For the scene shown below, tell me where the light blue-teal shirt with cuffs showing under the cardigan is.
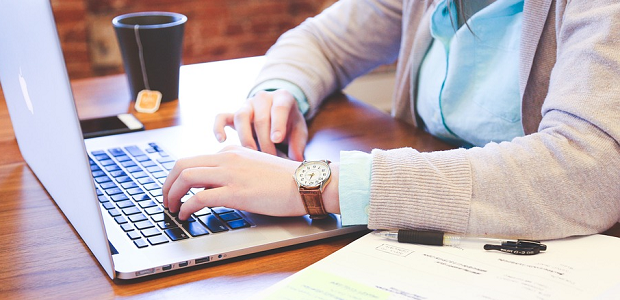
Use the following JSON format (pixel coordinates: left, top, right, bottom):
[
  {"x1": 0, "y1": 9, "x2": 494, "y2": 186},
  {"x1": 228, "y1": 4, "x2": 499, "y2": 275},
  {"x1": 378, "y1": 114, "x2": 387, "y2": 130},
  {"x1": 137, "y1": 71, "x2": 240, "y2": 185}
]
[{"x1": 254, "y1": 0, "x2": 524, "y2": 226}]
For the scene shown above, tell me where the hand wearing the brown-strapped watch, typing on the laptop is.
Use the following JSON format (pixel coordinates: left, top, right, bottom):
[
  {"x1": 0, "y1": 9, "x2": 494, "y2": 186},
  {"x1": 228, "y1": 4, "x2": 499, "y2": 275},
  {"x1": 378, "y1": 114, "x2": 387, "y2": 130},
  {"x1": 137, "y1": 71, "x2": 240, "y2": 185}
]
[{"x1": 163, "y1": 146, "x2": 339, "y2": 220}]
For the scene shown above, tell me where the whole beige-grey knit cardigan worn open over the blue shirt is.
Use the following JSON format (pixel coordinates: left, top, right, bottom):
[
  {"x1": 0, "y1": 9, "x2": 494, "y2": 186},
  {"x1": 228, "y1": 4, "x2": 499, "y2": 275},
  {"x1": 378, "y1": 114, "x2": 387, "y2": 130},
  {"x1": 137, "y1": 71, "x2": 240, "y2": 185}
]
[{"x1": 252, "y1": 0, "x2": 620, "y2": 239}]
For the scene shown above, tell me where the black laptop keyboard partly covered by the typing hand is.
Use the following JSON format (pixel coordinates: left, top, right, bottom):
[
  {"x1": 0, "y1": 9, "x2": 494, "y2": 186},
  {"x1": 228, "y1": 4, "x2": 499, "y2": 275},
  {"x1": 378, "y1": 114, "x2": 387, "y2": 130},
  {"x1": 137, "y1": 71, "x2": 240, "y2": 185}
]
[{"x1": 90, "y1": 143, "x2": 252, "y2": 248}]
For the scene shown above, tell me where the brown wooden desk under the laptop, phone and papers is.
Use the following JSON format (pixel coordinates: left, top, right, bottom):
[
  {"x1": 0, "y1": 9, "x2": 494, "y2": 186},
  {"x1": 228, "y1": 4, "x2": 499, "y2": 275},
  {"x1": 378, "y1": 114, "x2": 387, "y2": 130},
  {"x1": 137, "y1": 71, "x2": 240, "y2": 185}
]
[{"x1": 0, "y1": 58, "x2": 620, "y2": 299}]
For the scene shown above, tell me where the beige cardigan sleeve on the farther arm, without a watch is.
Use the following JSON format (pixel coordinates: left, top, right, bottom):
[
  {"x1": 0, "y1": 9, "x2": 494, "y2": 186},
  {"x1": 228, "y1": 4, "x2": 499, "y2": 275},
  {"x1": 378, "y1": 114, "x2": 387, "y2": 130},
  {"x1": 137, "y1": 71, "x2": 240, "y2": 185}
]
[{"x1": 256, "y1": 0, "x2": 402, "y2": 118}]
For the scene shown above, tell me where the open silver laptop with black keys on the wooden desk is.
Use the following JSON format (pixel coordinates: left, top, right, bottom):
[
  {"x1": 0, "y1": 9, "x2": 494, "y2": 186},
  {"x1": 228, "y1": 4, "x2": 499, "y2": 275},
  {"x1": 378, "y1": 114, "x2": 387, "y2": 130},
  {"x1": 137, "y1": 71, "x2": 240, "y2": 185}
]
[{"x1": 0, "y1": 0, "x2": 365, "y2": 279}]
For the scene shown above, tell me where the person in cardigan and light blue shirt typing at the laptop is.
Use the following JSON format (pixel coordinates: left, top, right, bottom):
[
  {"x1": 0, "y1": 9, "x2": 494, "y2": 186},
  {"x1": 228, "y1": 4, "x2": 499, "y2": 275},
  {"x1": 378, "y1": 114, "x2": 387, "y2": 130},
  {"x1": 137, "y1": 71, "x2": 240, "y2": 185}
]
[{"x1": 163, "y1": 0, "x2": 620, "y2": 239}]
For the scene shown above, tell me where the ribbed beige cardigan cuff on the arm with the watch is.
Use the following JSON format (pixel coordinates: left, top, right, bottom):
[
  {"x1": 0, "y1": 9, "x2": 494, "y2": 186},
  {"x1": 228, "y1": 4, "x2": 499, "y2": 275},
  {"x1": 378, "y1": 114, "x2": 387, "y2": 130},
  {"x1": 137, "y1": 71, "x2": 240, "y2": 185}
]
[{"x1": 368, "y1": 148, "x2": 472, "y2": 233}]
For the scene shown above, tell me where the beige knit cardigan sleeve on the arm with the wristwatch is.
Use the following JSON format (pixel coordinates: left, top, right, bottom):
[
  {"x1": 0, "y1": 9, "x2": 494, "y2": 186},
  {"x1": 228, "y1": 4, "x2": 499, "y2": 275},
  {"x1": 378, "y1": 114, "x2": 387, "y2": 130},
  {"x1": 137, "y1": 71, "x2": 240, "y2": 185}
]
[{"x1": 369, "y1": 1, "x2": 620, "y2": 239}]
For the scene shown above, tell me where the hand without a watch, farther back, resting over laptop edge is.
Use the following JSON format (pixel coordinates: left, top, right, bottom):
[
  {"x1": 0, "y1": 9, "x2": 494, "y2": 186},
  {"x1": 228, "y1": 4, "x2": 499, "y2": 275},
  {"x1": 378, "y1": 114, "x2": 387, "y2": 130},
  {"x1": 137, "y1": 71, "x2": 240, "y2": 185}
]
[{"x1": 213, "y1": 90, "x2": 308, "y2": 161}]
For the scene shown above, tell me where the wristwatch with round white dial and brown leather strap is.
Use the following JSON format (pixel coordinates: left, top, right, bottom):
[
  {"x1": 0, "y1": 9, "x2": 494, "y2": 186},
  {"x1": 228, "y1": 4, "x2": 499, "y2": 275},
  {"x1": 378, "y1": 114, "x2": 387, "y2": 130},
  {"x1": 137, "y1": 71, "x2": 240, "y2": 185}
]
[{"x1": 293, "y1": 160, "x2": 331, "y2": 219}]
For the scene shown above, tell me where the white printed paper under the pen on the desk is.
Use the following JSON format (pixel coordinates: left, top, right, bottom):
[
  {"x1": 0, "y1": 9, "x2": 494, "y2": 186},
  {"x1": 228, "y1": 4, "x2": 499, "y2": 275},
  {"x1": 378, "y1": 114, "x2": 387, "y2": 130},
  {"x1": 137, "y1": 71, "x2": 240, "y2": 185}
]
[{"x1": 261, "y1": 234, "x2": 620, "y2": 300}]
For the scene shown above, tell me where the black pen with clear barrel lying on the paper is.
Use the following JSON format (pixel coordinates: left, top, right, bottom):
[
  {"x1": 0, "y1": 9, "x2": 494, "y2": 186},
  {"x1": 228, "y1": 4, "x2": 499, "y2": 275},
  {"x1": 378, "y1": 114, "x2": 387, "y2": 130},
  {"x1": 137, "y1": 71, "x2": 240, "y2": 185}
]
[{"x1": 373, "y1": 229, "x2": 547, "y2": 255}]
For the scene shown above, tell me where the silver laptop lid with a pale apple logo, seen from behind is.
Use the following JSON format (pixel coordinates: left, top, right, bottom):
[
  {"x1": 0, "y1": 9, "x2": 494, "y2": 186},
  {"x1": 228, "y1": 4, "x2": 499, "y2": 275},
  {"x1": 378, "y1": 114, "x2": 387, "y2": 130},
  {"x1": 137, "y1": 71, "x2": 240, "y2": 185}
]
[{"x1": 0, "y1": 0, "x2": 114, "y2": 277}]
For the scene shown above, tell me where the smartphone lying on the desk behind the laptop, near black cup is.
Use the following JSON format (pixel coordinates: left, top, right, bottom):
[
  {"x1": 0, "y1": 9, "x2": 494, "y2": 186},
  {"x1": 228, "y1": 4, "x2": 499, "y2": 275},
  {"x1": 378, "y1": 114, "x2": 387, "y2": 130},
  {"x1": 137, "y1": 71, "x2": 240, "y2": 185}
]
[{"x1": 80, "y1": 114, "x2": 144, "y2": 139}]
